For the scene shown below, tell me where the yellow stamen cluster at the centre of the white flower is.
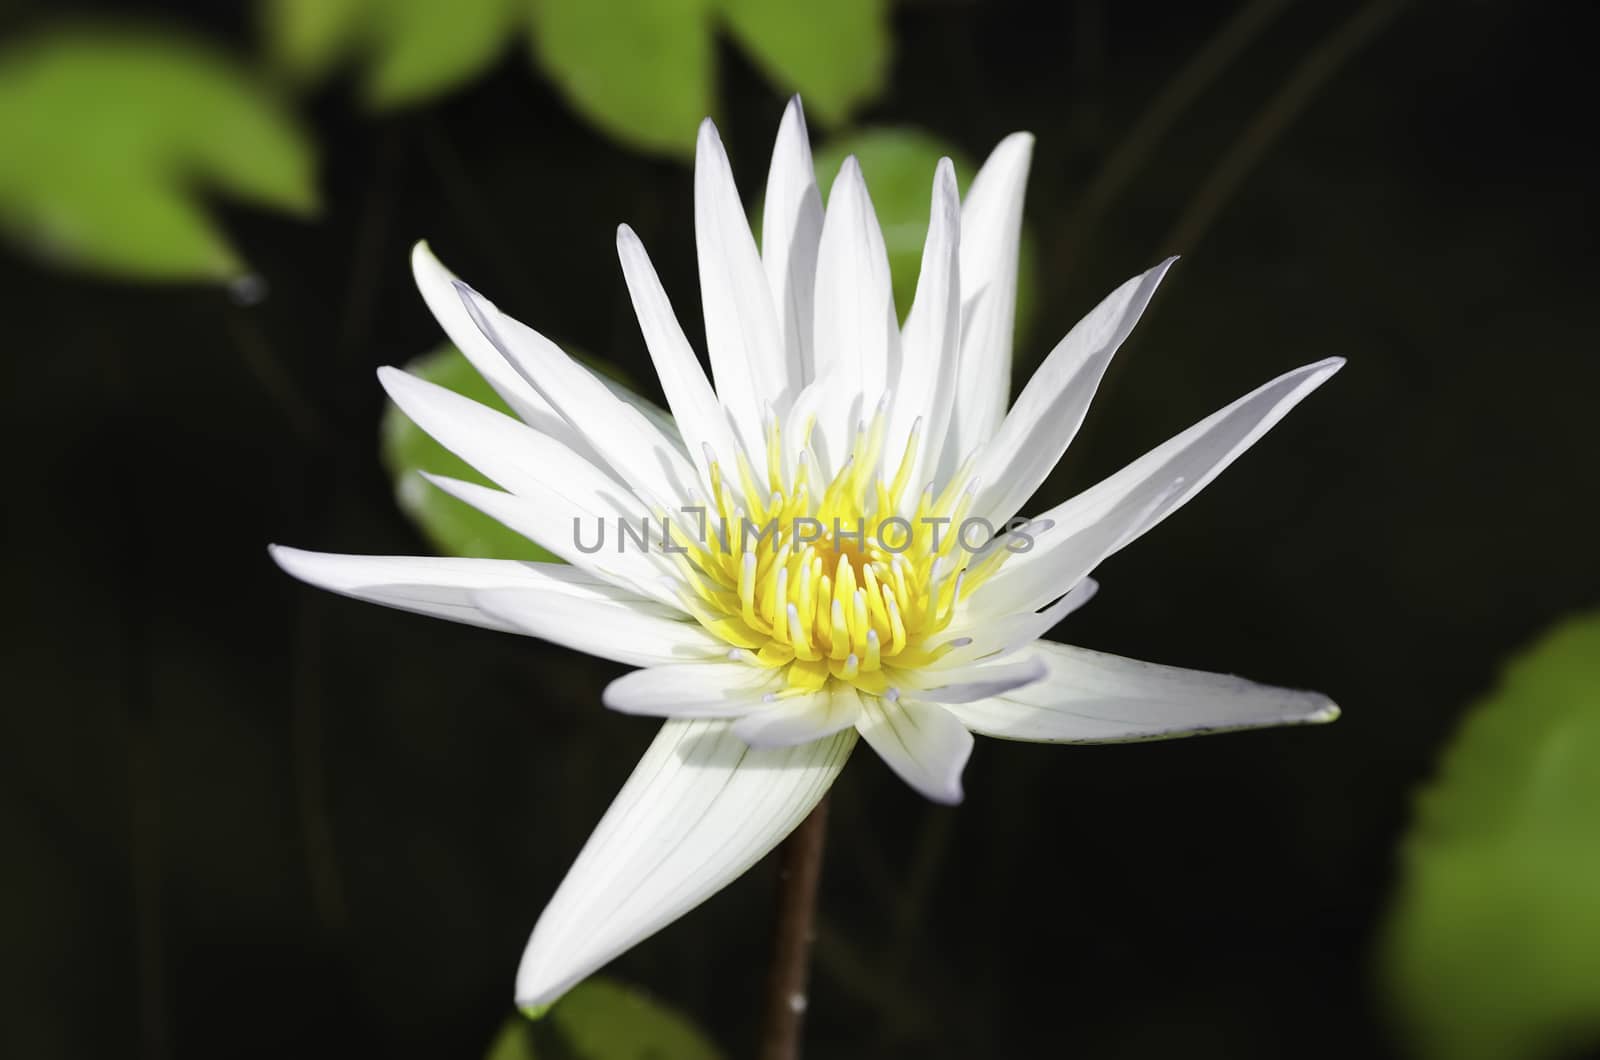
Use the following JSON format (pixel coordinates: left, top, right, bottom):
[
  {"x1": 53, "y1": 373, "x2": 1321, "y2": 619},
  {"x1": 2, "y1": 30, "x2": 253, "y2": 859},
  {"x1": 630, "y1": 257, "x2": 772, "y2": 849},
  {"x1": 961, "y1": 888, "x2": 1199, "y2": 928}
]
[{"x1": 678, "y1": 410, "x2": 1006, "y2": 695}]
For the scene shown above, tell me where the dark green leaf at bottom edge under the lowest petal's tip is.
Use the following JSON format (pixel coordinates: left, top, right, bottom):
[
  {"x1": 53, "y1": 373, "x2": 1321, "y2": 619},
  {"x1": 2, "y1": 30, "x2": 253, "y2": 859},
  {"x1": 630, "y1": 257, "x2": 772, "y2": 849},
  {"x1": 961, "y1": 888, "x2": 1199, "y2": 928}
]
[{"x1": 485, "y1": 977, "x2": 722, "y2": 1060}]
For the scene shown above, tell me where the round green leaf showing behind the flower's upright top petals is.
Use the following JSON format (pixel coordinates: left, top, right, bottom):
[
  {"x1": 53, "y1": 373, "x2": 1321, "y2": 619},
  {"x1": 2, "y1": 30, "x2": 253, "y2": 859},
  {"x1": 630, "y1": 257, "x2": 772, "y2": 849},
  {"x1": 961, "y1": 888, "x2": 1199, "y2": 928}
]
[{"x1": 814, "y1": 128, "x2": 1034, "y2": 341}]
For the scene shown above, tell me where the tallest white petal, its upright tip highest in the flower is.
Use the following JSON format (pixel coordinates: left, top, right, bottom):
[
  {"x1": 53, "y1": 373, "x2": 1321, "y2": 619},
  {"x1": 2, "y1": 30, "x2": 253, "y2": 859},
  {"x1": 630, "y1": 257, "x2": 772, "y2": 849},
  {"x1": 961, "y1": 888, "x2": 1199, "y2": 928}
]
[{"x1": 762, "y1": 96, "x2": 822, "y2": 390}]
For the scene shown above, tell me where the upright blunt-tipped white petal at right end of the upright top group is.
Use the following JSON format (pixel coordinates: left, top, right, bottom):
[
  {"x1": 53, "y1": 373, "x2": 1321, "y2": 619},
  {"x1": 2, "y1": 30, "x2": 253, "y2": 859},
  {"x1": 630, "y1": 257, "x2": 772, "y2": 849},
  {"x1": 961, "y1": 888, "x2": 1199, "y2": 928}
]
[{"x1": 946, "y1": 133, "x2": 1034, "y2": 468}]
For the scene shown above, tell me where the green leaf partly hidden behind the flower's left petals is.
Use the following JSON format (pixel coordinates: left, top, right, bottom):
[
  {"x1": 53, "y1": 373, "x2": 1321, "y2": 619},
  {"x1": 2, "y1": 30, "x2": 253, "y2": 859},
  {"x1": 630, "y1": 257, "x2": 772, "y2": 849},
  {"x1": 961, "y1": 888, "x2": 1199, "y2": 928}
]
[{"x1": 379, "y1": 346, "x2": 555, "y2": 560}]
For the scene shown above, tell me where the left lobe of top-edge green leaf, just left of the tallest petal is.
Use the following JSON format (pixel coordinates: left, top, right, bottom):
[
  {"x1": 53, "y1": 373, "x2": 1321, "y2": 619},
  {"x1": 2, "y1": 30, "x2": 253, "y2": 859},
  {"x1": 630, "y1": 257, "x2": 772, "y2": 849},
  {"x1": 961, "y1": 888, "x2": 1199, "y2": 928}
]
[{"x1": 533, "y1": 0, "x2": 715, "y2": 159}]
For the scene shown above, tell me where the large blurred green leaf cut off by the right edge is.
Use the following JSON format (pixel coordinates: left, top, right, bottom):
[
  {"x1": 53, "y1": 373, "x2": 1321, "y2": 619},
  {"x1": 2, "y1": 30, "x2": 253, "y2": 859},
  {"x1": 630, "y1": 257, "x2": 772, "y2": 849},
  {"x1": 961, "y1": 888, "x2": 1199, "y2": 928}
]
[{"x1": 1386, "y1": 615, "x2": 1600, "y2": 1060}]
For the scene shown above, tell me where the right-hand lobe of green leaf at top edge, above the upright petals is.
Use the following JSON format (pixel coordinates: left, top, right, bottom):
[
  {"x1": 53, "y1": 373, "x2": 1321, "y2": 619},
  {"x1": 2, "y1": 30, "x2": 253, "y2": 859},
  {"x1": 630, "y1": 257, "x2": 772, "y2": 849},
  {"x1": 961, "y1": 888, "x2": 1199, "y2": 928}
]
[{"x1": 720, "y1": 0, "x2": 891, "y2": 125}]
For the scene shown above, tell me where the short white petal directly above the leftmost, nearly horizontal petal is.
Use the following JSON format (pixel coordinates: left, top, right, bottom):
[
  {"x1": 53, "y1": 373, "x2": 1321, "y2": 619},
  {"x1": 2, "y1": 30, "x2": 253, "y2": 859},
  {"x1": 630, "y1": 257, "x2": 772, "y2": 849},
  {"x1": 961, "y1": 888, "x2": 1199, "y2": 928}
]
[{"x1": 422, "y1": 473, "x2": 678, "y2": 607}]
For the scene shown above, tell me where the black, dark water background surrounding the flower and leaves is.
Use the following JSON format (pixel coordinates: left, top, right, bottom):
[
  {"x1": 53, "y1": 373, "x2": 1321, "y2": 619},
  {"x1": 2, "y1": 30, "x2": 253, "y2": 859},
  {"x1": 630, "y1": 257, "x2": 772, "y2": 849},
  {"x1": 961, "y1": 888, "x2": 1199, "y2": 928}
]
[{"x1": 0, "y1": 0, "x2": 1600, "y2": 1057}]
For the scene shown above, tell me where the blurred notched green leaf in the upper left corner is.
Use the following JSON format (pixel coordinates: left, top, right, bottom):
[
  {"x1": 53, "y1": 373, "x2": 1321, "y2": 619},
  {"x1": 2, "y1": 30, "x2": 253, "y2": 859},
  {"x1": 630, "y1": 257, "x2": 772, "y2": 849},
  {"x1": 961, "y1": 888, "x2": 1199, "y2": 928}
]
[{"x1": 0, "y1": 29, "x2": 317, "y2": 280}]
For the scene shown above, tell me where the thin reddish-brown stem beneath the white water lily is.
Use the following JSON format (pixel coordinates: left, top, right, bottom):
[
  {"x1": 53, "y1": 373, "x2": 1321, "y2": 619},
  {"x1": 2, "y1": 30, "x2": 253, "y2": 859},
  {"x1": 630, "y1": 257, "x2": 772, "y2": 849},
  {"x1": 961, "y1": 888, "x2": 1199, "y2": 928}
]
[{"x1": 760, "y1": 796, "x2": 827, "y2": 1060}]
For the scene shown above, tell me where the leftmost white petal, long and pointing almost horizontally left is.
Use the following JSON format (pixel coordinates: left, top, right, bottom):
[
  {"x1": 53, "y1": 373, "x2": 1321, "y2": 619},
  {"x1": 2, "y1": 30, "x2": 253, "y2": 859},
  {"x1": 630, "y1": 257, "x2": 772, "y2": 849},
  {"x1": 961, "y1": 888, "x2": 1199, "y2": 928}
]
[{"x1": 267, "y1": 544, "x2": 656, "y2": 631}]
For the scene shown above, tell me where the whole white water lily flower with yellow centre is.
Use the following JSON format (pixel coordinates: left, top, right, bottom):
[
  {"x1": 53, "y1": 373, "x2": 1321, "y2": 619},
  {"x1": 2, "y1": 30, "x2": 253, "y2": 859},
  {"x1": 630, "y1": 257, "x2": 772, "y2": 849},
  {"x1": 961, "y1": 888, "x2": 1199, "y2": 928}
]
[{"x1": 274, "y1": 101, "x2": 1341, "y2": 1006}]
